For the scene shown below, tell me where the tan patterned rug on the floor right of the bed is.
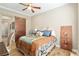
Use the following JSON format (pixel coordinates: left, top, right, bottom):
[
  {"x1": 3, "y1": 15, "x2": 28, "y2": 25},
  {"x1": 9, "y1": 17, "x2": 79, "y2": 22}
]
[{"x1": 47, "y1": 47, "x2": 70, "y2": 56}]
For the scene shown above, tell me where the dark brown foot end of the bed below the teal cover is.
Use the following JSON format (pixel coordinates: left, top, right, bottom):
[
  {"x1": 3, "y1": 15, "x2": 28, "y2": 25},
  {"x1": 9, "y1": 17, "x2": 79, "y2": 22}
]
[{"x1": 18, "y1": 40, "x2": 31, "y2": 55}]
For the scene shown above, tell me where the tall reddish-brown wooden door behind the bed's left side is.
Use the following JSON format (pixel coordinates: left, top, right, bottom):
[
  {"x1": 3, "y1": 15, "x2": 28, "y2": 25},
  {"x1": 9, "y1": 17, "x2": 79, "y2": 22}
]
[{"x1": 15, "y1": 17, "x2": 26, "y2": 45}]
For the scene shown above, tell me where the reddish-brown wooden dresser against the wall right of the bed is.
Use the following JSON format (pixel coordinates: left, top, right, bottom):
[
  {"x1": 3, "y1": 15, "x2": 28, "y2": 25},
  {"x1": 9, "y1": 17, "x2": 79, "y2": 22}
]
[{"x1": 60, "y1": 26, "x2": 72, "y2": 50}]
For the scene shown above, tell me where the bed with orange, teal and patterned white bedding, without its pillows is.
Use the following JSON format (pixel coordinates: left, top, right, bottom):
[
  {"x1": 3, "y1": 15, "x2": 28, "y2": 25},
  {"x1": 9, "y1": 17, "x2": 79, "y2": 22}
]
[{"x1": 17, "y1": 35, "x2": 56, "y2": 56}]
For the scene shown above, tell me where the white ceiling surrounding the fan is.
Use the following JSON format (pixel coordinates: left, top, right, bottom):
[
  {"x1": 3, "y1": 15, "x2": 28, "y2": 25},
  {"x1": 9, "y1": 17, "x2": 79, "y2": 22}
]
[{"x1": 0, "y1": 3, "x2": 66, "y2": 16}]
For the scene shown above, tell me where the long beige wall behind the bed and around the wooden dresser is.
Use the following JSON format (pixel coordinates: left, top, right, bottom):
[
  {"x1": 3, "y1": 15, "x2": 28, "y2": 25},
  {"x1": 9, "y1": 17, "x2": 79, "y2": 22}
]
[{"x1": 32, "y1": 4, "x2": 78, "y2": 49}]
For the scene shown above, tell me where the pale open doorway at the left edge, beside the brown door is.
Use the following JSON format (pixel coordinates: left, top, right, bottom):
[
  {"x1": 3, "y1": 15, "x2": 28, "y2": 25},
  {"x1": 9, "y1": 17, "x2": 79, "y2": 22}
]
[{"x1": 0, "y1": 15, "x2": 13, "y2": 46}]
